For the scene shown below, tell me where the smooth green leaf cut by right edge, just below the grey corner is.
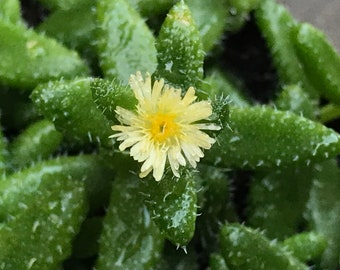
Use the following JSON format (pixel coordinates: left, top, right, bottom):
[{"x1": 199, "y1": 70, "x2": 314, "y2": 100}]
[{"x1": 294, "y1": 23, "x2": 340, "y2": 104}]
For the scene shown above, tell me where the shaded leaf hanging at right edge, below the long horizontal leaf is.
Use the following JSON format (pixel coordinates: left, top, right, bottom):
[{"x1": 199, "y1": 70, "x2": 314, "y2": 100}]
[{"x1": 308, "y1": 160, "x2": 340, "y2": 269}]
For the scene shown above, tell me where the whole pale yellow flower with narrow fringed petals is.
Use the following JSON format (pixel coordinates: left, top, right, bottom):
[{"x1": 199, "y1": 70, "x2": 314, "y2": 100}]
[{"x1": 110, "y1": 72, "x2": 220, "y2": 181}]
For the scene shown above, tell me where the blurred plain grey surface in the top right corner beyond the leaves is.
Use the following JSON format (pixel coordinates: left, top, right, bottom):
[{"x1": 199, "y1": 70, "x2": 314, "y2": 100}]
[{"x1": 278, "y1": 0, "x2": 340, "y2": 52}]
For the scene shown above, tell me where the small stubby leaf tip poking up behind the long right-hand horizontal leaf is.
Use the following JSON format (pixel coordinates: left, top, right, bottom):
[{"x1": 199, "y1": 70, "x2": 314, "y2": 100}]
[{"x1": 275, "y1": 85, "x2": 318, "y2": 120}]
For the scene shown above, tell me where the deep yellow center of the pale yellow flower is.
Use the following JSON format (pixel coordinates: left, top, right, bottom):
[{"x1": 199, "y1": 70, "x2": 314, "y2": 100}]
[{"x1": 150, "y1": 114, "x2": 179, "y2": 142}]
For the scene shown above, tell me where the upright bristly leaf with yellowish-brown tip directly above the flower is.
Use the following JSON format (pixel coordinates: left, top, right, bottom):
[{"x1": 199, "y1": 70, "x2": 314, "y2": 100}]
[{"x1": 155, "y1": 1, "x2": 204, "y2": 90}]
